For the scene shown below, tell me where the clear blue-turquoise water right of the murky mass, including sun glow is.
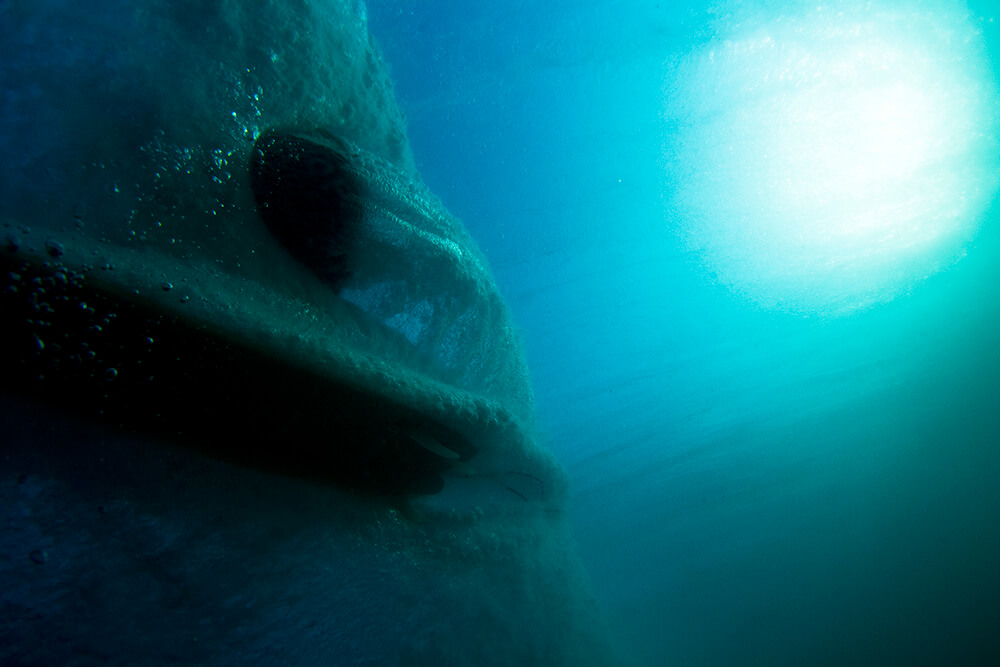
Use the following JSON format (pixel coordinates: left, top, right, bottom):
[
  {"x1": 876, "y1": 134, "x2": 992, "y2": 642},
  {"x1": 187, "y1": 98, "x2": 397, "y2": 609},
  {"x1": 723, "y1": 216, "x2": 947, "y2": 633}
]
[{"x1": 368, "y1": 0, "x2": 1000, "y2": 665}]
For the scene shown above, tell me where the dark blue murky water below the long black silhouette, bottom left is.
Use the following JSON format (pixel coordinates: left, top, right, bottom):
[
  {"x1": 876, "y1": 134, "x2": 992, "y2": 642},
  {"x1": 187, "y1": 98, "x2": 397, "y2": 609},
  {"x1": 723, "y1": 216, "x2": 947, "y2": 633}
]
[{"x1": 0, "y1": 399, "x2": 607, "y2": 665}]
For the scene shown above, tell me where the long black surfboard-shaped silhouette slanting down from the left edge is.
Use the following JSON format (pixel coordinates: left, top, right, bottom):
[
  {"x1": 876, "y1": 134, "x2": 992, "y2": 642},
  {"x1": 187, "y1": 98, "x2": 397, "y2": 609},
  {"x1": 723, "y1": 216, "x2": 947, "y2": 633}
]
[{"x1": 0, "y1": 250, "x2": 477, "y2": 495}]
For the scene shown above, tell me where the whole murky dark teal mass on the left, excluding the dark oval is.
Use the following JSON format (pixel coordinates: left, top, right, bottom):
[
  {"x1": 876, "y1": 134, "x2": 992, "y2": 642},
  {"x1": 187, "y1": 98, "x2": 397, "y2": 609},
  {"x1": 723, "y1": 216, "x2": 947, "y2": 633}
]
[{"x1": 0, "y1": 0, "x2": 608, "y2": 664}]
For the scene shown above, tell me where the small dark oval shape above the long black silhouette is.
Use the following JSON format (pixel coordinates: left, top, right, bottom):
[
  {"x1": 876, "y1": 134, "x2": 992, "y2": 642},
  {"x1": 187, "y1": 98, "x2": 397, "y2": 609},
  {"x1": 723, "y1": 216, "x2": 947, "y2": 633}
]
[{"x1": 250, "y1": 131, "x2": 362, "y2": 284}]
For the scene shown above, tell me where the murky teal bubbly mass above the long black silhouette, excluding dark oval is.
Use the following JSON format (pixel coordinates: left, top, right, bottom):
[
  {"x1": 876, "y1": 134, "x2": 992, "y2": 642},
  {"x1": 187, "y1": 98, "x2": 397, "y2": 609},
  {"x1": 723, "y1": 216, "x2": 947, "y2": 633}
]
[{"x1": 0, "y1": 1, "x2": 554, "y2": 486}]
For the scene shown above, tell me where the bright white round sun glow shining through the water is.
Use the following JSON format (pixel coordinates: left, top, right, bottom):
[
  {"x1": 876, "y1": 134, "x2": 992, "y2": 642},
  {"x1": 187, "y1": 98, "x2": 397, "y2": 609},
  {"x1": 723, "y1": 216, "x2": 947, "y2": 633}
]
[{"x1": 664, "y1": 7, "x2": 1000, "y2": 315}]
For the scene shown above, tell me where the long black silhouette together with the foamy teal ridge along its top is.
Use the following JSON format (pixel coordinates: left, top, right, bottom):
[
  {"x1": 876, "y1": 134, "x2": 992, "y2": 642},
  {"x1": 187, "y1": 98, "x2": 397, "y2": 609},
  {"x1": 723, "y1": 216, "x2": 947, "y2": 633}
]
[{"x1": 0, "y1": 239, "x2": 564, "y2": 501}]
